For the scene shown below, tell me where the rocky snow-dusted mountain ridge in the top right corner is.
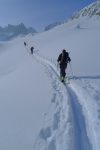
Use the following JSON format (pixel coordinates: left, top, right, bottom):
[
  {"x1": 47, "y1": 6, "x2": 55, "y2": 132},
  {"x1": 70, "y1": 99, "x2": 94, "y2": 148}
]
[{"x1": 71, "y1": 1, "x2": 100, "y2": 19}]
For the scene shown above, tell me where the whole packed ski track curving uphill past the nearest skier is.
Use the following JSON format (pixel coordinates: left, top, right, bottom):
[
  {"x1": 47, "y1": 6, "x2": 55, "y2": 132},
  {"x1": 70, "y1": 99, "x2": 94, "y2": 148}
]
[{"x1": 29, "y1": 54, "x2": 93, "y2": 150}]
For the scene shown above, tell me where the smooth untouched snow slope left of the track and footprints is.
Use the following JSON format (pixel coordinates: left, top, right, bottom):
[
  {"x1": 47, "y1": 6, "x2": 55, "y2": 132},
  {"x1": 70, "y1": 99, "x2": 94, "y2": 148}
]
[{"x1": 0, "y1": 40, "x2": 52, "y2": 150}]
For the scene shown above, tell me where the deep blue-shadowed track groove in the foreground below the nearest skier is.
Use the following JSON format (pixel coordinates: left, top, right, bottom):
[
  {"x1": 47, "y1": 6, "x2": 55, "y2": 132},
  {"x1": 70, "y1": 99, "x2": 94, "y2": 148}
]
[{"x1": 66, "y1": 86, "x2": 92, "y2": 150}]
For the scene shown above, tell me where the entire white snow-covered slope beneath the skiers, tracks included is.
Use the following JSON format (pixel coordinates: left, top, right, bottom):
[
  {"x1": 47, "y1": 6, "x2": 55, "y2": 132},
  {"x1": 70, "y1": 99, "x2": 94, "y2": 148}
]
[{"x1": 0, "y1": 17, "x2": 100, "y2": 150}]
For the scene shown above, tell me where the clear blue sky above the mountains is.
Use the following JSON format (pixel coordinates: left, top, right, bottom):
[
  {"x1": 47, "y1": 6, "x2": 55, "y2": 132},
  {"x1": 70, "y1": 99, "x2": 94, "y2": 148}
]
[{"x1": 0, "y1": 0, "x2": 96, "y2": 31}]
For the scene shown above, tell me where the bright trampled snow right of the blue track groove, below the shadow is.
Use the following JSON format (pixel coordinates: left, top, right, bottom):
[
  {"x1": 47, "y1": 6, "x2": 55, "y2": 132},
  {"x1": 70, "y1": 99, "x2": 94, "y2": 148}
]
[{"x1": 71, "y1": 78, "x2": 100, "y2": 150}]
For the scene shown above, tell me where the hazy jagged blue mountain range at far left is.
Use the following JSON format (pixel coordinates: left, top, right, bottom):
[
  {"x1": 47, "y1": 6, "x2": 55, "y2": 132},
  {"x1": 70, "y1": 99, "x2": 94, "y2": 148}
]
[{"x1": 0, "y1": 23, "x2": 36, "y2": 41}]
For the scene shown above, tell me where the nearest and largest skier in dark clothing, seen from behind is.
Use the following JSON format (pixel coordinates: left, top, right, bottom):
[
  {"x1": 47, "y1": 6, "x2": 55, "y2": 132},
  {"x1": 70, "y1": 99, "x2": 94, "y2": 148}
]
[{"x1": 57, "y1": 49, "x2": 71, "y2": 82}]
